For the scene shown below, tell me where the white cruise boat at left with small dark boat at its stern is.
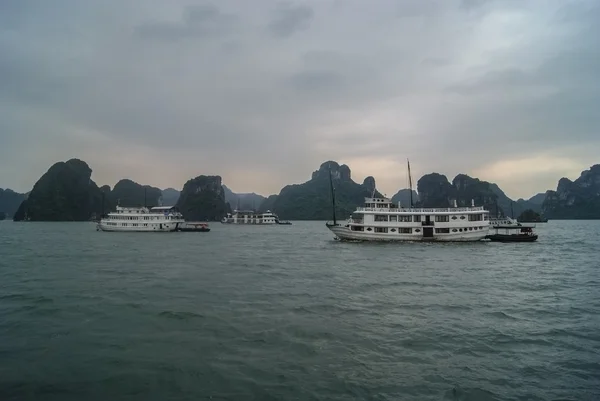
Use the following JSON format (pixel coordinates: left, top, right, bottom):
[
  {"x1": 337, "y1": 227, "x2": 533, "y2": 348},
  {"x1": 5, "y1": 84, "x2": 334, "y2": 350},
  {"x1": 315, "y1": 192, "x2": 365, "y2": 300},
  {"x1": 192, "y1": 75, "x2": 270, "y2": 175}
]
[{"x1": 97, "y1": 206, "x2": 185, "y2": 232}]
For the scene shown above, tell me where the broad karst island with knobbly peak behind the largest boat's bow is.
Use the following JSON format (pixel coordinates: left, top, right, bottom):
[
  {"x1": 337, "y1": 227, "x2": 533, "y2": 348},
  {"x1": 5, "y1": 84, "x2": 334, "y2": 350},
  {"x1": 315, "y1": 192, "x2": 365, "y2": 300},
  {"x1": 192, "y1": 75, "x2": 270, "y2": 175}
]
[{"x1": 260, "y1": 161, "x2": 381, "y2": 220}]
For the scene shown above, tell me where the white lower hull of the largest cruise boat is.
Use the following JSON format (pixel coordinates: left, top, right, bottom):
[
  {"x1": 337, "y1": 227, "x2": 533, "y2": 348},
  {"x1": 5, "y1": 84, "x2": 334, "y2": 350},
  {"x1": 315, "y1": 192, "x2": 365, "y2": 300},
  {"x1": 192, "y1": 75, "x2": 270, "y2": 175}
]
[{"x1": 327, "y1": 224, "x2": 488, "y2": 242}]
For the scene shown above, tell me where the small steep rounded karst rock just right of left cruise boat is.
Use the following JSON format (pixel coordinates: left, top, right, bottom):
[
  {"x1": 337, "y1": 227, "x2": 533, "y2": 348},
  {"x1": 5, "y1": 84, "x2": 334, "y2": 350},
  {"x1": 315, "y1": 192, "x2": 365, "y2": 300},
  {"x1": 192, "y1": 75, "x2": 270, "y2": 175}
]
[{"x1": 177, "y1": 175, "x2": 230, "y2": 221}]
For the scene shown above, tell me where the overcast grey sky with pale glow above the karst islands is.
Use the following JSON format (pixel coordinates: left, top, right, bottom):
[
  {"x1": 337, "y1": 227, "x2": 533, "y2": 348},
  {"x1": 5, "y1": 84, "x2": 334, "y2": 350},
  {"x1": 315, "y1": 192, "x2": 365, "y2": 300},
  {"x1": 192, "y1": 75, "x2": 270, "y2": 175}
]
[{"x1": 0, "y1": 0, "x2": 600, "y2": 198}]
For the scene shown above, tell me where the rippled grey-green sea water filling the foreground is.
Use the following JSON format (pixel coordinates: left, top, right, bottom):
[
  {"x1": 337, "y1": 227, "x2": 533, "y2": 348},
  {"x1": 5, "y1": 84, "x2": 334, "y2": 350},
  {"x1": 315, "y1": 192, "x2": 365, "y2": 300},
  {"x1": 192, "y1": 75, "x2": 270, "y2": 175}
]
[{"x1": 0, "y1": 221, "x2": 600, "y2": 401}]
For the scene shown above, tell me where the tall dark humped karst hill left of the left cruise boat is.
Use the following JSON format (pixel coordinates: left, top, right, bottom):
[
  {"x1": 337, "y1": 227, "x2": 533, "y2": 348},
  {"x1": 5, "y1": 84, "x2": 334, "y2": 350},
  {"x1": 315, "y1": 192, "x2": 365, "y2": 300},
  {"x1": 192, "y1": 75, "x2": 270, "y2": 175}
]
[{"x1": 13, "y1": 159, "x2": 102, "y2": 221}]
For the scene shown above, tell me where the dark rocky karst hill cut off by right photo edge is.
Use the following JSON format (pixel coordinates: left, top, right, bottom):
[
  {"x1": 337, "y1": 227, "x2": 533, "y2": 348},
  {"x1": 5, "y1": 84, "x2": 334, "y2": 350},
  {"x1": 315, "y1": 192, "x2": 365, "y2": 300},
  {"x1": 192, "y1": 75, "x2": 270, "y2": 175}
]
[{"x1": 542, "y1": 164, "x2": 600, "y2": 219}]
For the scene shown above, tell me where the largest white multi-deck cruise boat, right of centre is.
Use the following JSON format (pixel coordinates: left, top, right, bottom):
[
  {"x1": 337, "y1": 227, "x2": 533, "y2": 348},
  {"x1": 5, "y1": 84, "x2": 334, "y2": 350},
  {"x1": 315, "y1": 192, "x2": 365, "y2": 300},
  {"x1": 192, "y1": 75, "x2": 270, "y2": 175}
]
[{"x1": 327, "y1": 198, "x2": 490, "y2": 241}]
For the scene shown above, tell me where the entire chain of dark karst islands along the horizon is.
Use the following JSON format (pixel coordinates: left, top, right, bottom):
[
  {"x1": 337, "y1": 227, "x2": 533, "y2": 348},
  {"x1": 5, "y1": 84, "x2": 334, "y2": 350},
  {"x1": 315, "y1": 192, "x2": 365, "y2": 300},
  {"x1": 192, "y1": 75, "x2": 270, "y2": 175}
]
[{"x1": 10, "y1": 159, "x2": 600, "y2": 221}]
